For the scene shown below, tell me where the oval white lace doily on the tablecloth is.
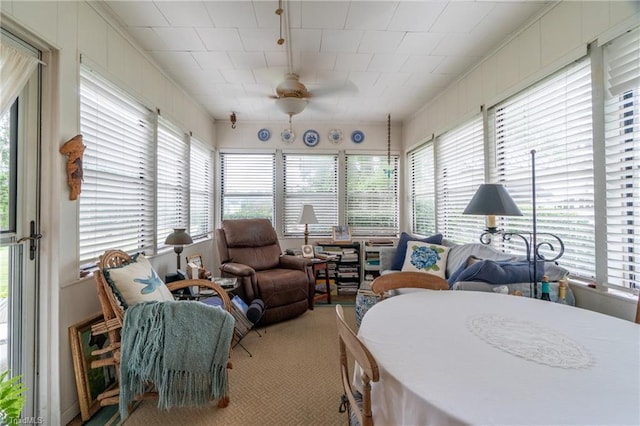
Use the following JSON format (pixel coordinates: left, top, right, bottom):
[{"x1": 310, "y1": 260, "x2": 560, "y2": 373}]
[{"x1": 467, "y1": 314, "x2": 592, "y2": 368}]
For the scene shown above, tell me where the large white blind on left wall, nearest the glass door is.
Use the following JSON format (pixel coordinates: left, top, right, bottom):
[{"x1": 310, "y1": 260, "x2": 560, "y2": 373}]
[{"x1": 79, "y1": 67, "x2": 154, "y2": 264}]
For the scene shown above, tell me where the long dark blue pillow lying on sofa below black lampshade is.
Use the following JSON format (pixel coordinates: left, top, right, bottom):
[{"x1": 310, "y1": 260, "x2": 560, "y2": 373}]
[{"x1": 449, "y1": 260, "x2": 544, "y2": 286}]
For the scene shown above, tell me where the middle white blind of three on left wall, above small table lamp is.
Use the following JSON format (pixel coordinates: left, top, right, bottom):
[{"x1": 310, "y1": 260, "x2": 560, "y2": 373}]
[{"x1": 156, "y1": 117, "x2": 189, "y2": 248}]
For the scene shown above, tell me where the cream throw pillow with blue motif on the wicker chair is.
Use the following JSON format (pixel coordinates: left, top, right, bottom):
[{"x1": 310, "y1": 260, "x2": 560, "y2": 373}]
[{"x1": 103, "y1": 254, "x2": 173, "y2": 309}]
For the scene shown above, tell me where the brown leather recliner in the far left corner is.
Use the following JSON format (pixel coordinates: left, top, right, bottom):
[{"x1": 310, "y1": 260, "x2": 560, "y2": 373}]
[{"x1": 216, "y1": 219, "x2": 315, "y2": 325}]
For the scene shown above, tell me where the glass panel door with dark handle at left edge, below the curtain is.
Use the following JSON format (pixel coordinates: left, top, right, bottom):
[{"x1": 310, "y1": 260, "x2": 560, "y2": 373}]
[{"x1": 0, "y1": 58, "x2": 39, "y2": 423}]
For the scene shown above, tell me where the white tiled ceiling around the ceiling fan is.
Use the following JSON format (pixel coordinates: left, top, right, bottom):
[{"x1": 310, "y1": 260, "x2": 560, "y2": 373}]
[{"x1": 104, "y1": 0, "x2": 550, "y2": 122}]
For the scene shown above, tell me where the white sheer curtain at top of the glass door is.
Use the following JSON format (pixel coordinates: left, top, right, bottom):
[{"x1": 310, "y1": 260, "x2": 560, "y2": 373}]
[{"x1": 0, "y1": 43, "x2": 38, "y2": 117}]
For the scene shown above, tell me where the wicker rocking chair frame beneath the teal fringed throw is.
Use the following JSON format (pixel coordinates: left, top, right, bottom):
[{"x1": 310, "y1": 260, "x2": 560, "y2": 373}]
[{"x1": 91, "y1": 250, "x2": 232, "y2": 408}]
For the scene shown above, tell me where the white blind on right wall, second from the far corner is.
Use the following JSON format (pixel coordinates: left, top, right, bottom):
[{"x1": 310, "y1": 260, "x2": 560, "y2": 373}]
[{"x1": 435, "y1": 116, "x2": 484, "y2": 243}]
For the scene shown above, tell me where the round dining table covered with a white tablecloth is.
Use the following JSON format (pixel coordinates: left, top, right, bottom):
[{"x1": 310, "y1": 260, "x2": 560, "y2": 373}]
[{"x1": 356, "y1": 291, "x2": 640, "y2": 426}]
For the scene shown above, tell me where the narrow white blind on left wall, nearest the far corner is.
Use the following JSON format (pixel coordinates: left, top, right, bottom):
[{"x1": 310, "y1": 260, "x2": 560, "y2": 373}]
[{"x1": 189, "y1": 138, "x2": 213, "y2": 239}]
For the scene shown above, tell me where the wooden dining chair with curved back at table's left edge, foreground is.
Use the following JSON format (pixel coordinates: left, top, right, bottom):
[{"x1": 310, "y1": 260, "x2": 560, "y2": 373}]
[{"x1": 336, "y1": 305, "x2": 380, "y2": 426}]
